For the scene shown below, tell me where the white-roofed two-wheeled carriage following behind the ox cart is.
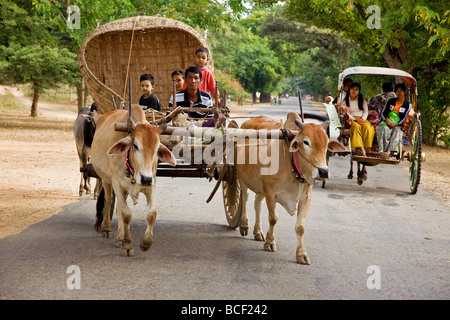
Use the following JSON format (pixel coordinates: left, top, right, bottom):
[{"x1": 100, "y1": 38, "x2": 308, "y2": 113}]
[{"x1": 325, "y1": 66, "x2": 425, "y2": 194}]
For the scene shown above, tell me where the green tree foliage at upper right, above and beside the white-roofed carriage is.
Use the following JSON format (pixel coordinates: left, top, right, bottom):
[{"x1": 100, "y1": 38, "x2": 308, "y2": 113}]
[{"x1": 280, "y1": 0, "x2": 450, "y2": 144}]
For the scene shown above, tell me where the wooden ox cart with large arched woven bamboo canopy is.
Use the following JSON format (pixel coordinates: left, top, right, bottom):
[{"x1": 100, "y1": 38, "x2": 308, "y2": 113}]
[{"x1": 79, "y1": 16, "x2": 314, "y2": 228}]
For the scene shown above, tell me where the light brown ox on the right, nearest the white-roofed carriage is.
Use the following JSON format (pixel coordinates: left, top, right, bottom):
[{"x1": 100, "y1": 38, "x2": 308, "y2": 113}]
[{"x1": 236, "y1": 112, "x2": 345, "y2": 264}]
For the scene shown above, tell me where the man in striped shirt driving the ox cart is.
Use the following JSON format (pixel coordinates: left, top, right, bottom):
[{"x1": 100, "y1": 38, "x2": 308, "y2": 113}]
[{"x1": 169, "y1": 66, "x2": 212, "y2": 125}]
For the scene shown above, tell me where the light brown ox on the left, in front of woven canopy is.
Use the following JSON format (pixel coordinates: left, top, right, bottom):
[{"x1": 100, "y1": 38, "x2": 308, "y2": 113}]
[{"x1": 91, "y1": 105, "x2": 176, "y2": 255}]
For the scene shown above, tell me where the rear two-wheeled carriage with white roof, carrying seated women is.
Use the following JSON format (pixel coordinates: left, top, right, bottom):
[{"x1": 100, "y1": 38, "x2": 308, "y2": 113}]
[{"x1": 325, "y1": 66, "x2": 425, "y2": 194}]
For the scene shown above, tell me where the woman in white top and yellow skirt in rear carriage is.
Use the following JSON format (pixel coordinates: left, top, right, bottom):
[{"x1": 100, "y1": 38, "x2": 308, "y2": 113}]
[{"x1": 344, "y1": 82, "x2": 375, "y2": 157}]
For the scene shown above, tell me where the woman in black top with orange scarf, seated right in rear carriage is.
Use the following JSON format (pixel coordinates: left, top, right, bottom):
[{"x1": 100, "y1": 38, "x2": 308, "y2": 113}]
[{"x1": 376, "y1": 83, "x2": 411, "y2": 159}]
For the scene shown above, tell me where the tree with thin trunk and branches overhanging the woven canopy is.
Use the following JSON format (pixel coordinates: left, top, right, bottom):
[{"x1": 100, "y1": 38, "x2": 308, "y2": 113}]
[{"x1": 23, "y1": 0, "x2": 250, "y2": 108}]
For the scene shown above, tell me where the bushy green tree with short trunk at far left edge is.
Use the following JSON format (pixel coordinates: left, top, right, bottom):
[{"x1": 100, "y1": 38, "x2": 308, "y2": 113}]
[{"x1": 0, "y1": 0, "x2": 77, "y2": 117}]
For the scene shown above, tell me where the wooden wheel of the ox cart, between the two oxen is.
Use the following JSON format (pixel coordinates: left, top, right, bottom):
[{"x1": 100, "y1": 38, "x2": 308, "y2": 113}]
[{"x1": 222, "y1": 165, "x2": 242, "y2": 229}]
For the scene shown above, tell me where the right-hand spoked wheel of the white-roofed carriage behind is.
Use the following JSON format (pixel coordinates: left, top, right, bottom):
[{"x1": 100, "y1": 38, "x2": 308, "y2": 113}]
[{"x1": 409, "y1": 119, "x2": 422, "y2": 194}]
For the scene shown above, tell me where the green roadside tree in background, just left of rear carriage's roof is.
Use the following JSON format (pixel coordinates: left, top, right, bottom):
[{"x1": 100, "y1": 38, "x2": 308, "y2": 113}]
[{"x1": 257, "y1": 12, "x2": 358, "y2": 98}]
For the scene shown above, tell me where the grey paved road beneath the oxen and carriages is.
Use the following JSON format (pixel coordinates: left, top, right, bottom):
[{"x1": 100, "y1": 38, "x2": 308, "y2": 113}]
[{"x1": 0, "y1": 98, "x2": 450, "y2": 304}]
